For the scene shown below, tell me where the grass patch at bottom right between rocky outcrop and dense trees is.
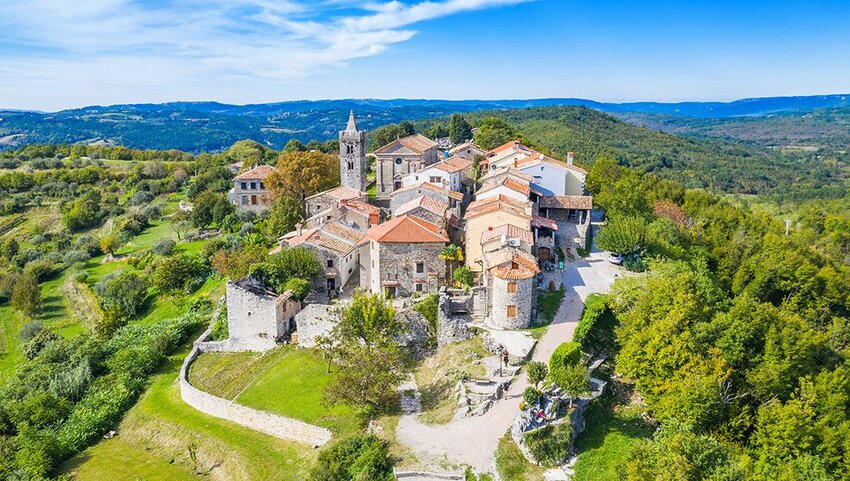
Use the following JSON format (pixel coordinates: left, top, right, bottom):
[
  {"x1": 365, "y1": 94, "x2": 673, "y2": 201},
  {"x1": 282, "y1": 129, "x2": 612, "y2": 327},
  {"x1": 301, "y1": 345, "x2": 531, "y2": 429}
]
[{"x1": 573, "y1": 399, "x2": 652, "y2": 481}]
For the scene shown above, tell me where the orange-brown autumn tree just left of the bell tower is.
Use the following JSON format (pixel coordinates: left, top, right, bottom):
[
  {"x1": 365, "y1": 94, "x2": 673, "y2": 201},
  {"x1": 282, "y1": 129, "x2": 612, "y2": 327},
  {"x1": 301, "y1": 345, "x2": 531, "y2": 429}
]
[{"x1": 266, "y1": 152, "x2": 339, "y2": 214}]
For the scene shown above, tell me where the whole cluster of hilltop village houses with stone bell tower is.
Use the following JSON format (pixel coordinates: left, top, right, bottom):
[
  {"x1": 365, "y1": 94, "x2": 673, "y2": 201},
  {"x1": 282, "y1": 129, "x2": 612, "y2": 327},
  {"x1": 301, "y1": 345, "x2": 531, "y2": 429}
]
[{"x1": 222, "y1": 112, "x2": 593, "y2": 337}]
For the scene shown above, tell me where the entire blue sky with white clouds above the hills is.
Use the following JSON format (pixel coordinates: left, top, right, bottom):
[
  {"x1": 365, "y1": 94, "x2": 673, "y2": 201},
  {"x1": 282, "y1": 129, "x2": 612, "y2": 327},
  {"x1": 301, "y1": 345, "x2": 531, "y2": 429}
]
[{"x1": 0, "y1": 0, "x2": 850, "y2": 110}]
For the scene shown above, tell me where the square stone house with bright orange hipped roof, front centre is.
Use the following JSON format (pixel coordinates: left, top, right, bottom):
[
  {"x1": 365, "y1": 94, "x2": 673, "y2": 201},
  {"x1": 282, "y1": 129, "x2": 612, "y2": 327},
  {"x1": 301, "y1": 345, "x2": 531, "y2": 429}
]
[{"x1": 360, "y1": 214, "x2": 449, "y2": 297}]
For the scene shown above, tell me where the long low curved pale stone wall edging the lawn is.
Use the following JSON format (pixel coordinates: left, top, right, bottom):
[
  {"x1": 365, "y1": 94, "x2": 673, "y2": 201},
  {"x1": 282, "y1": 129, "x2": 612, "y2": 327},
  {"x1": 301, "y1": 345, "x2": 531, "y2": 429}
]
[{"x1": 179, "y1": 316, "x2": 331, "y2": 446}]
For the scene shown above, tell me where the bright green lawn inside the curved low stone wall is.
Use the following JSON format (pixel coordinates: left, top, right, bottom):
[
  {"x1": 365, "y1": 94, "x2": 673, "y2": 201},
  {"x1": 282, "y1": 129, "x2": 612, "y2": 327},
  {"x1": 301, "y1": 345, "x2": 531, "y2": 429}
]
[{"x1": 236, "y1": 345, "x2": 362, "y2": 436}]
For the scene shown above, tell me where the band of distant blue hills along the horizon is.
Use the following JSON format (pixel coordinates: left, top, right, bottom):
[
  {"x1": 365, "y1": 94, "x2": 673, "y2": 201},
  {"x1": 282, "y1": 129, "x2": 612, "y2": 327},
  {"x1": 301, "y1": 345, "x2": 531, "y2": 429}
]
[{"x1": 0, "y1": 95, "x2": 850, "y2": 152}]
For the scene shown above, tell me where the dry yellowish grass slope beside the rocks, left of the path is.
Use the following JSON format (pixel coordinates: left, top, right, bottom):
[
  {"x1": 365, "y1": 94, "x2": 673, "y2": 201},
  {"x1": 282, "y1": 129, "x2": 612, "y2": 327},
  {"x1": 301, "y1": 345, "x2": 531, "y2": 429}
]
[{"x1": 414, "y1": 337, "x2": 490, "y2": 424}]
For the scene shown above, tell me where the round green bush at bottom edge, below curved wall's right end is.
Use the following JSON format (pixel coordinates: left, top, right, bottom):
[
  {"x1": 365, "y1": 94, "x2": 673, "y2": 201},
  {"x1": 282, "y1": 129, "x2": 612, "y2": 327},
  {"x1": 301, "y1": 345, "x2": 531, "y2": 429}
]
[{"x1": 310, "y1": 436, "x2": 395, "y2": 481}]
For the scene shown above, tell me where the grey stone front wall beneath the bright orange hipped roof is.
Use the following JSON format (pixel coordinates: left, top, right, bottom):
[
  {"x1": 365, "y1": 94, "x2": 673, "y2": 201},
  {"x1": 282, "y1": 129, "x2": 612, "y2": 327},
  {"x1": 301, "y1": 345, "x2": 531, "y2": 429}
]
[{"x1": 378, "y1": 242, "x2": 446, "y2": 297}]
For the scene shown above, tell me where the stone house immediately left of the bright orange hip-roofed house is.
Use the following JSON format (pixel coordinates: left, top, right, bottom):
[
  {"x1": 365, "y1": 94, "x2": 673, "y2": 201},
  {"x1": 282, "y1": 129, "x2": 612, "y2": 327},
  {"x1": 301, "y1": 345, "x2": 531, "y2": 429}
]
[{"x1": 282, "y1": 221, "x2": 365, "y2": 296}]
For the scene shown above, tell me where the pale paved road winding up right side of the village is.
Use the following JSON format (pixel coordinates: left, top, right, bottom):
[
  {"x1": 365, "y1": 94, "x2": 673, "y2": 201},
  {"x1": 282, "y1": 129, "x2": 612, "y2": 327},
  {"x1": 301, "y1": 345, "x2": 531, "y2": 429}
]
[{"x1": 396, "y1": 238, "x2": 618, "y2": 472}]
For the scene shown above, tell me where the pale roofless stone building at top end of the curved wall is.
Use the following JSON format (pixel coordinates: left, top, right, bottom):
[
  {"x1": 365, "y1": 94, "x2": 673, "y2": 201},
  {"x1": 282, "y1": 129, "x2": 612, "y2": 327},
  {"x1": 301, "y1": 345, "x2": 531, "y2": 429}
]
[{"x1": 226, "y1": 277, "x2": 301, "y2": 350}]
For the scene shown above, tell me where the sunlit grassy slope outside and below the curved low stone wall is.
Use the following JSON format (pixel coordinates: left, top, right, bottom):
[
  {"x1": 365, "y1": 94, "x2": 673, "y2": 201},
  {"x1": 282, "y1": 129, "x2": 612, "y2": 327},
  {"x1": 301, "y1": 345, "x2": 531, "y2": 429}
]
[{"x1": 62, "y1": 348, "x2": 317, "y2": 481}]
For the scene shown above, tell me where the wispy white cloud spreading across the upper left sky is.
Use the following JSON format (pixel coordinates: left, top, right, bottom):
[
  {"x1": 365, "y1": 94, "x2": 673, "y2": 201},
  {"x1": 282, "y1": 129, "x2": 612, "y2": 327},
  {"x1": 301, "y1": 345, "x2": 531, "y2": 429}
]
[{"x1": 0, "y1": 0, "x2": 530, "y2": 107}]
